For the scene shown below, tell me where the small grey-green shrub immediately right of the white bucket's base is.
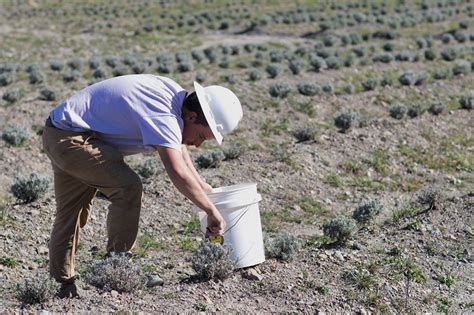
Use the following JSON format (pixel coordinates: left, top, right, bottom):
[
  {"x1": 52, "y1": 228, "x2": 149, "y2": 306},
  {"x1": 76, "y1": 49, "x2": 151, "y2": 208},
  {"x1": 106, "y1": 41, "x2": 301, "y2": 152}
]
[{"x1": 265, "y1": 233, "x2": 301, "y2": 261}]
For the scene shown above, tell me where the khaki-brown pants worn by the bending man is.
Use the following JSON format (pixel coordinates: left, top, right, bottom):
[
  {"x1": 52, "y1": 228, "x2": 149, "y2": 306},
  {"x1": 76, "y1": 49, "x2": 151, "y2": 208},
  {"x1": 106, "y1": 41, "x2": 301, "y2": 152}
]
[{"x1": 43, "y1": 126, "x2": 142, "y2": 283}]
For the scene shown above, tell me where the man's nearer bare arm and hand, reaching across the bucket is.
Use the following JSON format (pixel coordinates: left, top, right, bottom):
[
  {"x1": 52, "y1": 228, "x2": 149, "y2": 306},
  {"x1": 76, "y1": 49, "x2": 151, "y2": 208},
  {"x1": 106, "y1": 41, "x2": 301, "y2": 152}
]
[{"x1": 158, "y1": 147, "x2": 225, "y2": 235}]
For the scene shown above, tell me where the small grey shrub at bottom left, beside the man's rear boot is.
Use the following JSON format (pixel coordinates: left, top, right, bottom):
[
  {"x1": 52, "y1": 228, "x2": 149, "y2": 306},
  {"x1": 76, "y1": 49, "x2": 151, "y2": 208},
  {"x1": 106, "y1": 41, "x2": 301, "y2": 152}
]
[{"x1": 16, "y1": 275, "x2": 59, "y2": 304}]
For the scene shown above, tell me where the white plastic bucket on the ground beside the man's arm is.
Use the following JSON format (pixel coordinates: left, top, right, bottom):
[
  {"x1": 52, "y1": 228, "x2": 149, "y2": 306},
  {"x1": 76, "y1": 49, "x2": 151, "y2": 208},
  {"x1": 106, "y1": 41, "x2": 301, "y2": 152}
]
[{"x1": 199, "y1": 183, "x2": 265, "y2": 268}]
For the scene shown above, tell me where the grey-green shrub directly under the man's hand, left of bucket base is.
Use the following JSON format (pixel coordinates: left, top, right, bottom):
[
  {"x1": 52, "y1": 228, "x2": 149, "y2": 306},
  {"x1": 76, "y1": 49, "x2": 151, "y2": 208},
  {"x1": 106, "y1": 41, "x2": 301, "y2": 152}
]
[{"x1": 188, "y1": 241, "x2": 235, "y2": 280}]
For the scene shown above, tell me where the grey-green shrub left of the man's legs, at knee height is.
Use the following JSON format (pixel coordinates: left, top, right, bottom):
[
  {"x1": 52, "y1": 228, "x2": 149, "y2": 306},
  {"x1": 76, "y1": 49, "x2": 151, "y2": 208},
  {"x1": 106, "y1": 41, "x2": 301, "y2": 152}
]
[{"x1": 10, "y1": 173, "x2": 49, "y2": 202}]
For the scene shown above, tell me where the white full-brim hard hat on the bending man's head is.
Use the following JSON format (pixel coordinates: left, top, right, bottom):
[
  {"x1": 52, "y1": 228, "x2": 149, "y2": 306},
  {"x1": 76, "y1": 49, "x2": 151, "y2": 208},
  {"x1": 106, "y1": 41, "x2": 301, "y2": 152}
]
[{"x1": 194, "y1": 82, "x2": 243, "y2": 144}]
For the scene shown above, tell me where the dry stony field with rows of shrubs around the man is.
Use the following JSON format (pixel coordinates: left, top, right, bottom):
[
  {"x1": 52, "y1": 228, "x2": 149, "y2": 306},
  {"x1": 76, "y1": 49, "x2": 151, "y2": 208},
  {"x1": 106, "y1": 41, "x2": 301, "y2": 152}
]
[{"x1": 0, "y1": 0, "x2": 474, "y2": 314}]
